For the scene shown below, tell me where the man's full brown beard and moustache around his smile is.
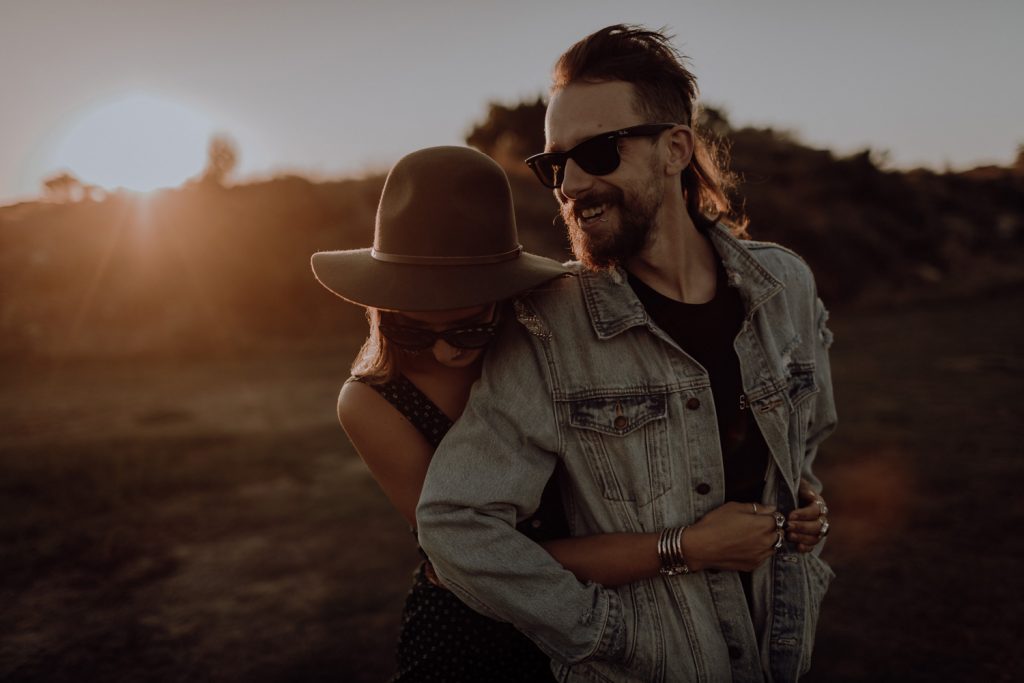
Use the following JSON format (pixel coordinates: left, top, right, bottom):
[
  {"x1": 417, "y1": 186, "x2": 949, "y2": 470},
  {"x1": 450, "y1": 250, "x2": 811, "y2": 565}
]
[{"x1": 561, "y1": 179, "x2": 662, "y2": 270}]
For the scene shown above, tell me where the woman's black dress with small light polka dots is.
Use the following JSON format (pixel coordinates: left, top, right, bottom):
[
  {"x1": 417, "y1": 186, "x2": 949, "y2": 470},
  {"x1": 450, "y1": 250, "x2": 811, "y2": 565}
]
[{"x1": 350, "y1": 376, "x2": 568, "y2": 683}]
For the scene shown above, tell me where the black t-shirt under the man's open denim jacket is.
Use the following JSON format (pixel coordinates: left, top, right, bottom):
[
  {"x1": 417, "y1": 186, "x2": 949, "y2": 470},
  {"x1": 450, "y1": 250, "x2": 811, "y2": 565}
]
[{"x1": 630, "y1": 263, "x2": 768, "y2": 503}]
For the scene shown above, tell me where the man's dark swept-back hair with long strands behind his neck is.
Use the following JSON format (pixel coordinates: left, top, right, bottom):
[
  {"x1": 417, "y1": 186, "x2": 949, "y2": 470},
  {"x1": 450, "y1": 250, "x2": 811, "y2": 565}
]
[{"x1": 551, "y1": 24, "x2": 748, "y2": 237}]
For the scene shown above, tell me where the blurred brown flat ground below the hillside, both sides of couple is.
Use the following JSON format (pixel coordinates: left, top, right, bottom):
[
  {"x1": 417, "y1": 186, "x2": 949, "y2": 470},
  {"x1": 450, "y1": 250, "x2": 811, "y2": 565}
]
[{"x1": 0, "y1": 290, "x2": 1024, "y2": 682}]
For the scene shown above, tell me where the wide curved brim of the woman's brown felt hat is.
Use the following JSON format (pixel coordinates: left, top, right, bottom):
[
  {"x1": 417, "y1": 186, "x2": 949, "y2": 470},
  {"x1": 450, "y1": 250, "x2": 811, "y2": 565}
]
[{"x1": 310, "y1": 249, "x2": 569, "y2": 311}]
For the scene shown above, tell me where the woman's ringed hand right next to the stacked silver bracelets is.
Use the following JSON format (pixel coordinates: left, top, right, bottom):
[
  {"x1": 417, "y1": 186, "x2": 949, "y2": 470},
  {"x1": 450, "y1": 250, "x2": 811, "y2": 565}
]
[{"x1": 683, "y1": 503, "x2": 781, "y2": 571}]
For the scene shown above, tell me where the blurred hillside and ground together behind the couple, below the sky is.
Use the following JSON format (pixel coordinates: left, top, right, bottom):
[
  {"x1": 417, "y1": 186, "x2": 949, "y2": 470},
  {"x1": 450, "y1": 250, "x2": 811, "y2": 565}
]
[{"x1": 0, "y1": 101, "x2": 1024, "y2": 681}]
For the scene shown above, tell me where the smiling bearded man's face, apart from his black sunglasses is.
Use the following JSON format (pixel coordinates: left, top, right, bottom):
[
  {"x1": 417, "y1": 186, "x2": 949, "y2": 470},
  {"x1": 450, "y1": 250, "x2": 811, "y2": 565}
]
[{"x1": 546, "y1": 81, "x2": 665, "y2": 268}]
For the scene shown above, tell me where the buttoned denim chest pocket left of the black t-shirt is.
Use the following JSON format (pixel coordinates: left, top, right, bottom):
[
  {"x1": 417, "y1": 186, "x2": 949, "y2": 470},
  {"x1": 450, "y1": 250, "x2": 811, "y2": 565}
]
[{"x1": 567, "y1": 393, "x2": 672, "y2": 506}]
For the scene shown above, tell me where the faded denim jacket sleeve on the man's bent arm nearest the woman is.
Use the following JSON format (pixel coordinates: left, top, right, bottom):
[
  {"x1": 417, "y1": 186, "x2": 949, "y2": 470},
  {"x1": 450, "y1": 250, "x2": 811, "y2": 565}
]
[{"x1": 417, "y1": 321, "x2": 626, "y2": 665}]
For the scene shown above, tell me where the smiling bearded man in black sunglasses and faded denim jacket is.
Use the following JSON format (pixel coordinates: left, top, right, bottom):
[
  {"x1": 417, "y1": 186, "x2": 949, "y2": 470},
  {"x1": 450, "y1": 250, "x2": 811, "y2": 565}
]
[{"x1": 417, "y1": 26, "x2": 836, "y2": 682}]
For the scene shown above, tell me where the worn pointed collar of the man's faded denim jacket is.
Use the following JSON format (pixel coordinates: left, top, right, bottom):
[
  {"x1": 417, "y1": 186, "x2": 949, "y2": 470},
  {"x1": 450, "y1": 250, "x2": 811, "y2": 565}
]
[{"x1": 580, "y1": 223, "x2": 783, "y2": 339}]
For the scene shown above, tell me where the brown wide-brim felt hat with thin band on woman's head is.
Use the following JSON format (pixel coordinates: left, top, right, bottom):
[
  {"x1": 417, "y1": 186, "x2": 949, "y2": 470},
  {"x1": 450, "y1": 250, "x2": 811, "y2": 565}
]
[{"x1": 312, "y1": 146, "x2": 568, "y2": 311}]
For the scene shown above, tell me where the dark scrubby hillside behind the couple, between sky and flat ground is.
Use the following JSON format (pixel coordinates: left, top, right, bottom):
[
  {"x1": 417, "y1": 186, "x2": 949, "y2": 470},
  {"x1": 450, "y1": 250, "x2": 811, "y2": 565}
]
[{"x1": 0, "y1": 122, "x2": 1024, "y2": 356}]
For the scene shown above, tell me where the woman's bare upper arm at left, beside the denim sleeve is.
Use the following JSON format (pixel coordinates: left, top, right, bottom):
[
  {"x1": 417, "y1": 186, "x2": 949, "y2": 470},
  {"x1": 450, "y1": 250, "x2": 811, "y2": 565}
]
[{"x1": 338, "y1": 382, "x2": 433, "y2": 526}]
